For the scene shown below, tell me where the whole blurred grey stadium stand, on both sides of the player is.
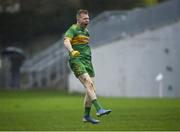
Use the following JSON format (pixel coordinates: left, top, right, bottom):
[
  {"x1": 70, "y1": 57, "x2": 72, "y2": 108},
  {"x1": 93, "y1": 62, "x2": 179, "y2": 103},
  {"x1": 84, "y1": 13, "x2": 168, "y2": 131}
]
[{"x1": 21, "y1": 0, "x2": 180, "y2": 89}]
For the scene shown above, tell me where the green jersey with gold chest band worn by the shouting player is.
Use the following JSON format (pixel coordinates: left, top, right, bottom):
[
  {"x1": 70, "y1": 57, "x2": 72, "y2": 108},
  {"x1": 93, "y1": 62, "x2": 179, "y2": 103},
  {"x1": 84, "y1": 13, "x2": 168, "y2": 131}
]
[{"x1": 65, "y1": 24, "x2": 91, "y2": 59}]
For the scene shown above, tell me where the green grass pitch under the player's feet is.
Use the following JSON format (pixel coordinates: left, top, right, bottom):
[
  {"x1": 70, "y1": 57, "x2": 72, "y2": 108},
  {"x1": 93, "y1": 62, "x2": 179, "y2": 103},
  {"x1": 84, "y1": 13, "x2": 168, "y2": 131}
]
[{"x1": 0, "y1": 91, "x2": 180, "y2": 131}]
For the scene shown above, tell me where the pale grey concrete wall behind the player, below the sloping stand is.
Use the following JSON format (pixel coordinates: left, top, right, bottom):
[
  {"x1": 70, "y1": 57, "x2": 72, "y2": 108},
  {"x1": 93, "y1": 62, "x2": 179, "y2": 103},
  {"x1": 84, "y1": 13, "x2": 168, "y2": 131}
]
[{"x1": 69, "y1": 22, "x2": 180, "y2": 97}]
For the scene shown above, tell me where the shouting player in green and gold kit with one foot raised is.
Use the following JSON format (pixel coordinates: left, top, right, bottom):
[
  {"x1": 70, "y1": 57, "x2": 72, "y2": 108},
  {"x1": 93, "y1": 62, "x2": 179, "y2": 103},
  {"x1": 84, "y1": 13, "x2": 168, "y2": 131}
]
[{"x1": 64, "y1": 10, "x2": 111, "y2": 124}]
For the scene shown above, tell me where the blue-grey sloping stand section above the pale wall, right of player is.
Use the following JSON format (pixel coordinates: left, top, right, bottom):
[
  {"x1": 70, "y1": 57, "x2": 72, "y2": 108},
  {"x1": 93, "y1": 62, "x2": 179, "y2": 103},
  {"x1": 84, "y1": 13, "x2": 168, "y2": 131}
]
[{"x1": 89, "y1": 0, "x2": 180, "y2": 47}]
